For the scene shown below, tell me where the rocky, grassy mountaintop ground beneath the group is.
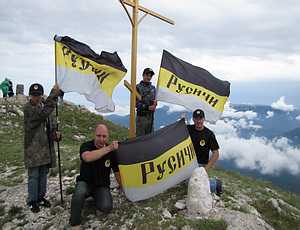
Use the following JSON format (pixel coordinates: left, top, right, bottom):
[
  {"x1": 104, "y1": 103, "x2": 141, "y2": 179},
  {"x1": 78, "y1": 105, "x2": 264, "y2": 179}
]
[{"x1": 0, "y1": 97, "x2": 300, "y2": 230}]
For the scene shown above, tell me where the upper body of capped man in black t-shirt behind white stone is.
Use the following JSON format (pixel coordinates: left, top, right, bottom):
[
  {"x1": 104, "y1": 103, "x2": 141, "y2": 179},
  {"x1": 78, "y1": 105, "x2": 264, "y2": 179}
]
[{"x1": 187, "y1": 109, "x2": 219, "y2": 171}]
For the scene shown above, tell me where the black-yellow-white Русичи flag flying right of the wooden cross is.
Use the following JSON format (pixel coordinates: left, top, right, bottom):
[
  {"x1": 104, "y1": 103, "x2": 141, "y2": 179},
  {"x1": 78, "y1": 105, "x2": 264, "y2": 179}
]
[{"x1": 157, "y1": 50, "x2": 230, "y2": 122}]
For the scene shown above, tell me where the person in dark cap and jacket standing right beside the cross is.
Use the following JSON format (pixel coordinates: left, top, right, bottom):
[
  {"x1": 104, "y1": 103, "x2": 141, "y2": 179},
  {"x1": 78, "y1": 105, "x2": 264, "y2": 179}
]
[{"x1": 136, "y1": 68, "x2": 157, "y2": 136}]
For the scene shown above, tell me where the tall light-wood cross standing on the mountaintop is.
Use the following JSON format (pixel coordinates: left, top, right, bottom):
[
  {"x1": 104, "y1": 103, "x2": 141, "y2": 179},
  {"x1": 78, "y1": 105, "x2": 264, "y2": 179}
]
[{"x1": 119, "y1": 0, "x2": 175, "y2": 137}]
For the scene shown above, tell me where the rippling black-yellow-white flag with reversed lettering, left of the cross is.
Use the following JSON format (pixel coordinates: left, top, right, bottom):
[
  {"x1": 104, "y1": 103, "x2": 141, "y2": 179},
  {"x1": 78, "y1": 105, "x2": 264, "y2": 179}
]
[{"x1": 54, "y1": 36, "x2": 127, "y2": 112}]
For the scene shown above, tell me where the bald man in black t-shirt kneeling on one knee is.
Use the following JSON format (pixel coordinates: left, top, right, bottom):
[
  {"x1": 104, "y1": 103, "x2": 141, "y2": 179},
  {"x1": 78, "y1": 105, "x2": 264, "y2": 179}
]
[{"x1": 70, "y1": 124, "x2": 121, "y2": 229}]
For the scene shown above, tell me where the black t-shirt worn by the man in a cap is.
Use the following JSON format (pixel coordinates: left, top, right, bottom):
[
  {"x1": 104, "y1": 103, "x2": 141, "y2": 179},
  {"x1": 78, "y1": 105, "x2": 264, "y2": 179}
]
[{"x1": 187, "y1": 125, "x2": 219, "y2": 164}]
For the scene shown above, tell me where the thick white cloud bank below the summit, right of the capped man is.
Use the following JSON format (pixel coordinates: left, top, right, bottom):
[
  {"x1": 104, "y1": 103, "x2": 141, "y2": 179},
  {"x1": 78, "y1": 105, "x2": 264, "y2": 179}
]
[{"x1": 209, "y1": 117, "x2": 300, "y2": 175}]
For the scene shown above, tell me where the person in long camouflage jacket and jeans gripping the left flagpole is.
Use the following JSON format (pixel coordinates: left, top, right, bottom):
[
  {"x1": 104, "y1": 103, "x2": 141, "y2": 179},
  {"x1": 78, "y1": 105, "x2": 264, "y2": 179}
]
[{"x1": 24, "y1": 83, "x2": 62, "y2": 212}]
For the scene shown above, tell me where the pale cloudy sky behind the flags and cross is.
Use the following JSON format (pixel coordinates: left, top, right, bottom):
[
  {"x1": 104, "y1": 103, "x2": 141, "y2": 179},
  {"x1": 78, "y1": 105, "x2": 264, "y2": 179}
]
[{"x1": 0, "y1": 0, "x2": 300, "y2": 111}]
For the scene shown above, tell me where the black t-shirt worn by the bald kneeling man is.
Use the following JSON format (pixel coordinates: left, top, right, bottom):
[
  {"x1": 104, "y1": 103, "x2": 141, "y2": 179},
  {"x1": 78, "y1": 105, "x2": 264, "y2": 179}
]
[{"x1": 77, "y1": 140, "x2": 119, "y2": 187}]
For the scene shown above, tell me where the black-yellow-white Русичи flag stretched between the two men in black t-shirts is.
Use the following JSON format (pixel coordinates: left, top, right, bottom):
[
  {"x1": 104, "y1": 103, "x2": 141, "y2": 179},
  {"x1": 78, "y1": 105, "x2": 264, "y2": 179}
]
[{"x1": 117, "y1": 119, "x2": 198, "y2": 201}]
